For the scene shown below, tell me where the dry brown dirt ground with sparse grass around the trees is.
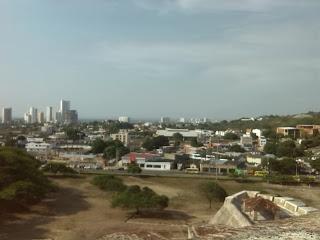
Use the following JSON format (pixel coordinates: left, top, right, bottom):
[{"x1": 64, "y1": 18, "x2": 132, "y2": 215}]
[{"x1": 0, "y1": 177, "x2": 320, "y2": 240}]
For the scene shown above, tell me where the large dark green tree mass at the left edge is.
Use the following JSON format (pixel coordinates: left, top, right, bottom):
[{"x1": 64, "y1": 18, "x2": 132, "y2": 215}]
[{"x1": 0, "y1": 148, "x2": 52, "y2": 211}]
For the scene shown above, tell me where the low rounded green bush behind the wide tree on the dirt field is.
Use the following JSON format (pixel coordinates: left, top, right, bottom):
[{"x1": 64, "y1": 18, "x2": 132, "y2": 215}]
[{"x1": 92, "y1": 175, "x2": 126, "y2": 192}]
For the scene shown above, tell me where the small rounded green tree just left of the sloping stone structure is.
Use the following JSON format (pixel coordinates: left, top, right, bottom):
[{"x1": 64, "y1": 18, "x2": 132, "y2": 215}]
[{"x1": 200, "y1": 182, "x2": 228, "y2": 209}]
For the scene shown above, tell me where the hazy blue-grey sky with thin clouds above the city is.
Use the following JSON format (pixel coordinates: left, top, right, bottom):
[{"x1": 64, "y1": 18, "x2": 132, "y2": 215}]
[{"x1": 0, "y1": 0, "x2": 320, "y2": 119}]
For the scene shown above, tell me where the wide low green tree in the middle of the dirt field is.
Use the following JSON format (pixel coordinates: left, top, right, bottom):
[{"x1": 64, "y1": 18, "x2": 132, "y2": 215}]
[{"x1": 112, "y1": 185, "x2": 169, "y2": 214}]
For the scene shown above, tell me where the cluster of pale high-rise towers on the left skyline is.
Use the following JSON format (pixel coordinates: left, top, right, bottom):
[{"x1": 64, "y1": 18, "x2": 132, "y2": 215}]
[{"x1": 24, "y1": 100, "x2": 78, "y2": 124}]
